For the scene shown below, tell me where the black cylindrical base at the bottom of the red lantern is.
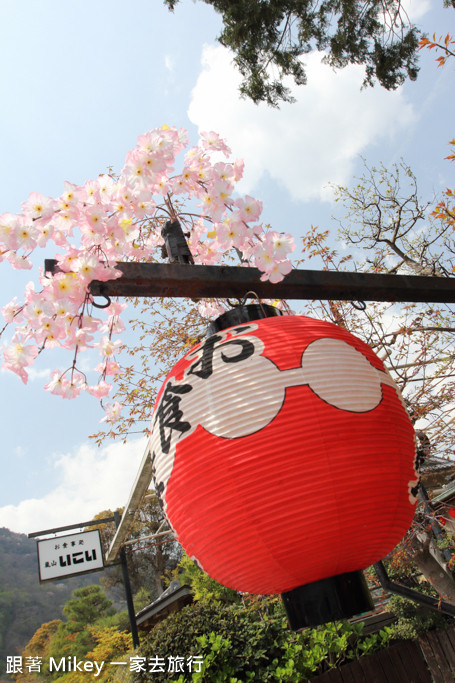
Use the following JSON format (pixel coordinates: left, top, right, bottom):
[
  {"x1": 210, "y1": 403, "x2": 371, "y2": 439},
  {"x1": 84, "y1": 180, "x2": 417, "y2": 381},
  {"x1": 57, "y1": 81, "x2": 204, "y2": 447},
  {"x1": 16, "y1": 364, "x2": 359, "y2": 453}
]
[{"x1": 281, "y1": 571, "x2": 373, "y2": 631}]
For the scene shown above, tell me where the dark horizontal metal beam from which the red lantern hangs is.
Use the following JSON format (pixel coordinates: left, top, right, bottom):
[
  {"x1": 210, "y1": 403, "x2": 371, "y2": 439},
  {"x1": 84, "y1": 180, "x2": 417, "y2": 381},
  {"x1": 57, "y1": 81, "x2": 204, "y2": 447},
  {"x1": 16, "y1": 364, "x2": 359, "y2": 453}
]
[{"x1": 45, "y1": 260, "x2": 455, "y2": 303}]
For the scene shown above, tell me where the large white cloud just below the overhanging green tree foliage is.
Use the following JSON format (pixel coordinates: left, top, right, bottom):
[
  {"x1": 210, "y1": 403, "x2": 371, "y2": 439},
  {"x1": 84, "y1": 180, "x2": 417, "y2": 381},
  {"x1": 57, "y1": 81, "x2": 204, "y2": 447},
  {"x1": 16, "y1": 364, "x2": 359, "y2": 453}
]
[{"x1": 188, "y1": 46, "x2": 415, "y2": 200}]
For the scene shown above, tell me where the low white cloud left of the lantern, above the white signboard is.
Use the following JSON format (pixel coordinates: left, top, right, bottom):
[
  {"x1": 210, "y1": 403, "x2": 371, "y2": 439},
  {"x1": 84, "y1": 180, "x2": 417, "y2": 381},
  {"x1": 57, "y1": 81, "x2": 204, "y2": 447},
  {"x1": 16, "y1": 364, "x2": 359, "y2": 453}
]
[{"x1": 0, "y1": 439, "x2": 145, "y2": 533}]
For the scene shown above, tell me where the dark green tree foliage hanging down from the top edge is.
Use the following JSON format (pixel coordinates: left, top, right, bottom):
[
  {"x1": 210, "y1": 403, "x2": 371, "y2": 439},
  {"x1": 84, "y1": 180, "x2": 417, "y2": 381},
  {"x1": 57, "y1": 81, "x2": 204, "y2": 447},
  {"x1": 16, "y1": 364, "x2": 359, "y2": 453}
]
[{"x1": 164, "y1": 0, "x2": 419, "y2": 106}]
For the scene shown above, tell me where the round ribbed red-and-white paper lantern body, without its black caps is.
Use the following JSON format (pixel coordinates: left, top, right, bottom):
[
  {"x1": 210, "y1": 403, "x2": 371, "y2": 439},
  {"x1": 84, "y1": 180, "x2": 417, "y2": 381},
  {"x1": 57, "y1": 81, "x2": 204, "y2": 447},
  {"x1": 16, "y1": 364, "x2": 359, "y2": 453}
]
[{"x1": 151, "y1": 316, "x2": 417, "y2": 594}]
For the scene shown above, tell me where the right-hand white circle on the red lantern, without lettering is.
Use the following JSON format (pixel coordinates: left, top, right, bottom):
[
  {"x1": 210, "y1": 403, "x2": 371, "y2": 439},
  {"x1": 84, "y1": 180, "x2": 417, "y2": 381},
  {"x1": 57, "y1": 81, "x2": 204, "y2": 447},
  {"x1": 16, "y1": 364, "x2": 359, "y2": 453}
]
[{"x1": 302, "y1": 337, "x2": 389, "y2": 413}]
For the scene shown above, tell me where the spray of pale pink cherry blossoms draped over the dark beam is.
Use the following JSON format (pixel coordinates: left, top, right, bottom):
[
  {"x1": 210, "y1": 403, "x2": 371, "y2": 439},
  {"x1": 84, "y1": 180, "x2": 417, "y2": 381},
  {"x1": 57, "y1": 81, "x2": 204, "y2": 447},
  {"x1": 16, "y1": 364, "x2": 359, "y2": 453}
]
[{"x1": 0, "y1": 125, "x2": 294, "y2": 414}]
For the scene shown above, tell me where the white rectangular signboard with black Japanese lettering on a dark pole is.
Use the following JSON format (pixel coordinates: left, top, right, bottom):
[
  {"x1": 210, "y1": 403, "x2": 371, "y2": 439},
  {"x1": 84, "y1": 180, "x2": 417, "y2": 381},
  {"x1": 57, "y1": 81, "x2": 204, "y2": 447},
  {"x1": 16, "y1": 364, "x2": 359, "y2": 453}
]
[{"x1": 38, "y1": 529, "x2": 104, "y2": 582}]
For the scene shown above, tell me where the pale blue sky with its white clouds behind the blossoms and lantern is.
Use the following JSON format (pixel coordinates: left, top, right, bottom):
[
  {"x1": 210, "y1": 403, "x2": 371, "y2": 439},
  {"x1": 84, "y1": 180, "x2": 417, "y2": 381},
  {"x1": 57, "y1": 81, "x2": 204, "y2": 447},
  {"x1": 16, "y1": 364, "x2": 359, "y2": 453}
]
[{"x1": 0, "y1": 0, "x2": 455, "y2": 533}]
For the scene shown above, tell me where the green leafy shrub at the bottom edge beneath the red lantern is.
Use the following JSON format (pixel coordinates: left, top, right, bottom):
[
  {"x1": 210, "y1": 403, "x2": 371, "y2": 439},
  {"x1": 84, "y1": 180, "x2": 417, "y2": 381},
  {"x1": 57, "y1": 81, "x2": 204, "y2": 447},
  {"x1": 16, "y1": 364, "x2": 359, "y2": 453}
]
[{"x1": 135, "y1": 596, "x2": 389, "y2": 683}]
